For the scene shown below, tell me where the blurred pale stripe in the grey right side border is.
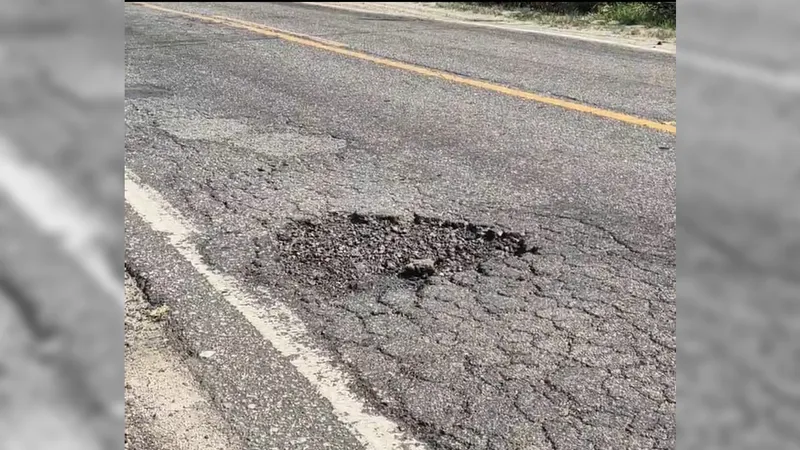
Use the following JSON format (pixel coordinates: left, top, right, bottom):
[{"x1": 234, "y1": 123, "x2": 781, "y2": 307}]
[{"x1": 677, "y1": 50, "x2": 800, "y2": 94}]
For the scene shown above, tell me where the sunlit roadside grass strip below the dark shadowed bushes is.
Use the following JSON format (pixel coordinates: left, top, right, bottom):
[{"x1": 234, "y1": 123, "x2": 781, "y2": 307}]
[{"x1": 436, "y1": 2, "x2": 676, "y2": 40}]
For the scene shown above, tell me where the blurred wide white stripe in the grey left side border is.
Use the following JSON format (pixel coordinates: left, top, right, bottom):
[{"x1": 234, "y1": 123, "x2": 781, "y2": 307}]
[{"x1": 0, "y1": 136, "x2": 123, "y2": 306}]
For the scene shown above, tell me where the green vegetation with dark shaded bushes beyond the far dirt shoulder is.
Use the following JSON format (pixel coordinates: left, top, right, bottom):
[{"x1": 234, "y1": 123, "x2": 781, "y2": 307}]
[{"x1": 438, "y1": 2, "x2": 676, "y2": 37}]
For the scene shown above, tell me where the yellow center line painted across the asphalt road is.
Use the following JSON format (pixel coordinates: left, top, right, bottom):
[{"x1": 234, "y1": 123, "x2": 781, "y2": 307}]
[{"x1": 134, "y1": 2, "x2": 677, "y2": 134}]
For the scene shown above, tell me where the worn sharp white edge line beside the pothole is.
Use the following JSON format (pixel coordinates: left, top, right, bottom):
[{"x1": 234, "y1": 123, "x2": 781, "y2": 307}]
[{"x1": 125, "y1": 170, "x2": 425, "y2": 450}]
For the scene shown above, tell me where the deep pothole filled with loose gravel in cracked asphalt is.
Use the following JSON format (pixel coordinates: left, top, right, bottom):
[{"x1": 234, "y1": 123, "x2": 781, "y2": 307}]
[{"x1": 277, "y1": 213, "x2": 538, "y2": 290}]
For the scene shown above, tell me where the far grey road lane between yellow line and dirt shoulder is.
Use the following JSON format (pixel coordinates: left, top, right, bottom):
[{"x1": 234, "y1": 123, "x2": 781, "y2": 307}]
[{"x1": 167, "y1": 2, "x2": 676, "y2": 121}]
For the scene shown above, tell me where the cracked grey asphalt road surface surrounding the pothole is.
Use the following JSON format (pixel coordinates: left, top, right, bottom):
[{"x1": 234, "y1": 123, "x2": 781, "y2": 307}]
[{"x1": 125, "y1": 3, "x2": 676, "y2": 449}]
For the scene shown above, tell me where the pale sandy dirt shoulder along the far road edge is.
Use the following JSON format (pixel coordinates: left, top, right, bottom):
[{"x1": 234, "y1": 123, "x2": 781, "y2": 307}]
[{"x1": 304, "y1": 2, "x2": 677, "y2": 53}]
